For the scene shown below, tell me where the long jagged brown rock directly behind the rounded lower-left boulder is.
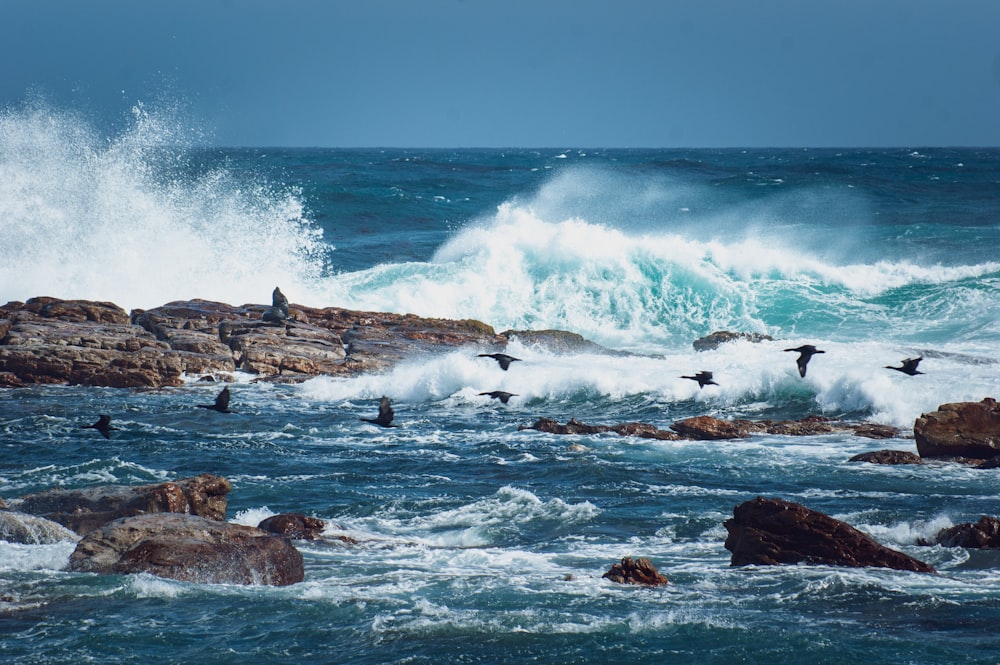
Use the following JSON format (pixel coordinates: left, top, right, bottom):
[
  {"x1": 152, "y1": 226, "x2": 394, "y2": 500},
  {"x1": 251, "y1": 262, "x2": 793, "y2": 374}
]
[{"x1": 11, "y1": 473, "x2": 231, "y2": 535}]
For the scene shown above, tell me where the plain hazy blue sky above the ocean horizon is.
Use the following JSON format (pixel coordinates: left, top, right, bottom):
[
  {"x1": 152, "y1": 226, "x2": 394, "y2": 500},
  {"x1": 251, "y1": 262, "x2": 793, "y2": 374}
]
[{"x1": 0, "y1": 0, "x2": 1000, "y2": 148}]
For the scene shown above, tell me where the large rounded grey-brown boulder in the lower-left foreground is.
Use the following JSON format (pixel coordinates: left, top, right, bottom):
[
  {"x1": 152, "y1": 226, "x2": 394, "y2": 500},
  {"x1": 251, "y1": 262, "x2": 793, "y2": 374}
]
[{"x1": 69, "y1": 513, "x2": 304, "y2": 586}]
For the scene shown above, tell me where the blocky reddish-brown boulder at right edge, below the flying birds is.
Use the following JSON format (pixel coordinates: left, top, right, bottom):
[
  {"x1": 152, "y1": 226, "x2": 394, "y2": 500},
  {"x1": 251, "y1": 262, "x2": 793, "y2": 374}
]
[{"x1": 913, "y1": 397, "x2": 1000, "y2": 459}]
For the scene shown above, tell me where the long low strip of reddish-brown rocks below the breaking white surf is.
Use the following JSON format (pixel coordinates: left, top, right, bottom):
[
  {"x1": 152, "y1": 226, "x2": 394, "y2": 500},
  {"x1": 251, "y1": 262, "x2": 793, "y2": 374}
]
[{"x1": 519, "y1": 416, "x2": 899, "y2": 441}]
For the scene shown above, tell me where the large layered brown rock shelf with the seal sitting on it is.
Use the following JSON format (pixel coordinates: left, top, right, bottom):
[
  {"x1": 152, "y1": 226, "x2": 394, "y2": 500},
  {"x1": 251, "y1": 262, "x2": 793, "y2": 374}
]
[{"x1": 0, "y1": 298, "x2": 508, "y2": 387}]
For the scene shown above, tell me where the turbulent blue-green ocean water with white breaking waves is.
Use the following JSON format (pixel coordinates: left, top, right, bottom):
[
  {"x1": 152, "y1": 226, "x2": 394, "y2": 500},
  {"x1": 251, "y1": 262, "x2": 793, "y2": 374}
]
[{"x1": 0, "y1": 106, "x2": 1000, "y2": 664}]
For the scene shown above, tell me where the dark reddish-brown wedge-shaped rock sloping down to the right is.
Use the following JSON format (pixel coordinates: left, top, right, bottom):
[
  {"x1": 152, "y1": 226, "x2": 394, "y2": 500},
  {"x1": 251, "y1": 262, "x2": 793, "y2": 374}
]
[{"x1": 725, "y1": 497, "x2": 936, "y2": 573}]
